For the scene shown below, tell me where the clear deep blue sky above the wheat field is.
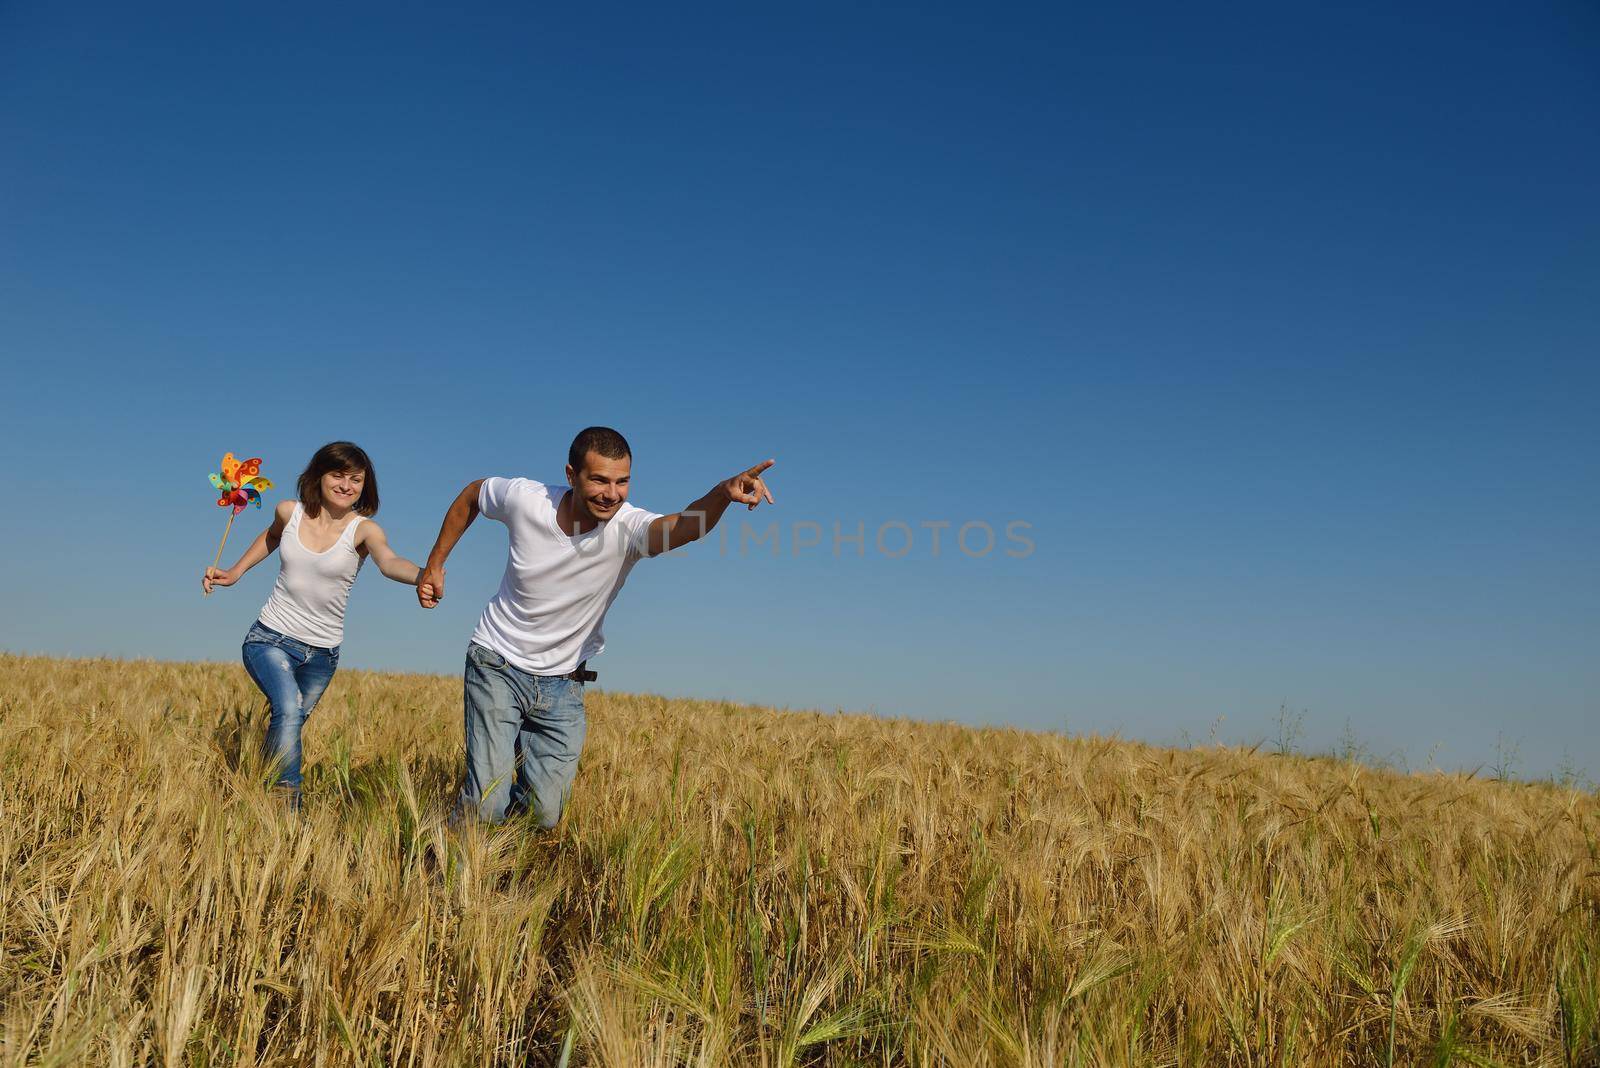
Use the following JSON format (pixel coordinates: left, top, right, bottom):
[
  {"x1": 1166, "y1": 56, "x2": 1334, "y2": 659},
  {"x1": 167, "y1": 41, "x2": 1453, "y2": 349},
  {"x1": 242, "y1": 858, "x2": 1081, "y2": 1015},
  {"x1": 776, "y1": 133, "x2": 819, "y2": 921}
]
[{"x1": 0, "y1": 0, "x2": 1600, "y2": 775}]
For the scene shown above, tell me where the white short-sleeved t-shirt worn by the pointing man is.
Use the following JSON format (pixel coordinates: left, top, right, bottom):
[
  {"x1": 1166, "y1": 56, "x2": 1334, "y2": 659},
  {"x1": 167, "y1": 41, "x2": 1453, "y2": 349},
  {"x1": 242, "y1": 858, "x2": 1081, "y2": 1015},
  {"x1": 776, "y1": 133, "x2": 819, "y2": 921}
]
[{"x1": 472, "y1": 478, "x2": 661, "y2": 675}]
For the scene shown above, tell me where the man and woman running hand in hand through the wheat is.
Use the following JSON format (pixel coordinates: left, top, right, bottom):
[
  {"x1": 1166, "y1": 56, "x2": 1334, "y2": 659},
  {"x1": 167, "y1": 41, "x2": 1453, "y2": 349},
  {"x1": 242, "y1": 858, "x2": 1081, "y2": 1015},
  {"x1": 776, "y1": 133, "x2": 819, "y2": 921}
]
[{"x1": 202, "y1": 427, "x2": 773, "y2": 827}]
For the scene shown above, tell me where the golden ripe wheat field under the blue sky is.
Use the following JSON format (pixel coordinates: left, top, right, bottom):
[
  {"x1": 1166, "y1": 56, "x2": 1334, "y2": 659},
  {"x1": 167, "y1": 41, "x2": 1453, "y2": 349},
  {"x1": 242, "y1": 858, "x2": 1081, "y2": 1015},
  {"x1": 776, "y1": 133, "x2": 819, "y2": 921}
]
[{"x1": 0, "y1": 656, "x2": 1600, "y2": 1068}]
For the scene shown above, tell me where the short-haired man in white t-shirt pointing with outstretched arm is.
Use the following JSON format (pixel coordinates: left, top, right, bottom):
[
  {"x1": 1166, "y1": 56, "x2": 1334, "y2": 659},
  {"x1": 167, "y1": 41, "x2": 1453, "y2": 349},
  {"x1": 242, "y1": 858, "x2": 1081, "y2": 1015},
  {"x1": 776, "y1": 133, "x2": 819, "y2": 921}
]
[{"x1": 416, "y1": 427, "x2": 774, "y2": 827}]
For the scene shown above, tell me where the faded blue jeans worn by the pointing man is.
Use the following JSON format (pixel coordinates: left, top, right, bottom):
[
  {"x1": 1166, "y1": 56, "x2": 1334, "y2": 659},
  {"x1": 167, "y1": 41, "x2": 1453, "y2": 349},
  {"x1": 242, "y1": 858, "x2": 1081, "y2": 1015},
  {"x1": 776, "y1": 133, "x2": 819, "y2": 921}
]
[{"x1": 456, "y1": 641, "x2": 587, "y2": 827}]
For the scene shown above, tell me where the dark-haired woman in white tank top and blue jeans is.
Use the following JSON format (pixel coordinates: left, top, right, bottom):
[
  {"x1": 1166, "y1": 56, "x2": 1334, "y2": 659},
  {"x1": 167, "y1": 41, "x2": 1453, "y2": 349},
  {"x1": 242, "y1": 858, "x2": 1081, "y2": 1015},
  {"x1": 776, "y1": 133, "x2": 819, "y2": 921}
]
[{"x1": 200, "y1": 441, "x2": 421, "y2": 806}]
